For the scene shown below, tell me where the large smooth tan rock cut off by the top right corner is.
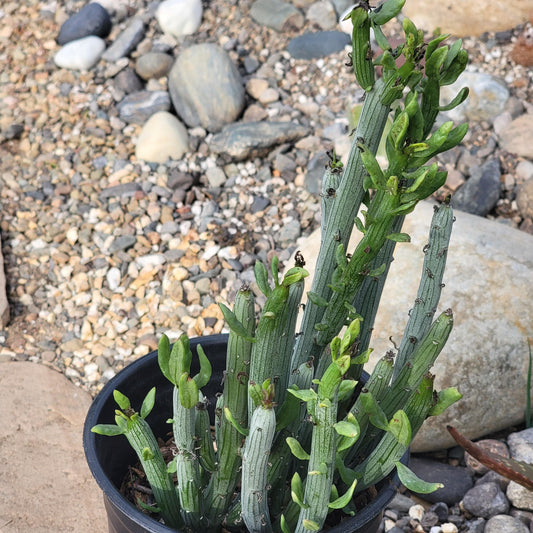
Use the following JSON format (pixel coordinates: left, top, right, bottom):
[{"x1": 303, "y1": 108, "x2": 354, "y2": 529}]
[{"x1": 403, "y1": 0, "x2": 531, "y2": 37}]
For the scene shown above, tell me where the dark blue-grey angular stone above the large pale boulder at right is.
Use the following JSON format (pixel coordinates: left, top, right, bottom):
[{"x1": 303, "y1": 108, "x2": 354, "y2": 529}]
[{"x1": 452, "y1": 159, "x2": 501, "y2": 216}]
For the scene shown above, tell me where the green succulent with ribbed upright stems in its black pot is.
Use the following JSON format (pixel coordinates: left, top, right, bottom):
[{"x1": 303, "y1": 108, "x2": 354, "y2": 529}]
[{"x1": 84, "y1": 0, "x2": 468, "y2": 533}]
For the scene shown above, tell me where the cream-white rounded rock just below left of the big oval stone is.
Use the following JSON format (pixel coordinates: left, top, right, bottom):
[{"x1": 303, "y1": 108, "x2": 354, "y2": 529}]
[{"x1": 135, "y1": 111, "x2": 189, "y2": 163}]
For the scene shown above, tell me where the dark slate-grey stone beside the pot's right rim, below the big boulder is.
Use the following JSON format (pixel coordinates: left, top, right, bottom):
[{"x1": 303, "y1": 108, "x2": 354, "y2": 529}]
[{"x1": 409, "y1": 457, "x2": 473, "y2": 505}]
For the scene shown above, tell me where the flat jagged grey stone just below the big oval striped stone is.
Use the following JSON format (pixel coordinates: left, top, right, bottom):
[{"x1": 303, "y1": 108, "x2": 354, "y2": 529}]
[{"x1": 209, "y1": 122, "x2": 309, "y2": 161}]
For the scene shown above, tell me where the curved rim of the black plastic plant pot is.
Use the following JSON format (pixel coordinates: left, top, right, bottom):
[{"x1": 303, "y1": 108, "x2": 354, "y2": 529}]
[{"x1": 83, "y1": 334, "x2": 409, "y2": 533}]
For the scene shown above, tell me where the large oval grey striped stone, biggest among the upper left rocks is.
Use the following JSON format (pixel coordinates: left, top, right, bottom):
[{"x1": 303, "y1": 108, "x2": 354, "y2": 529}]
[{"x1": 168, "y1": 43, "x2": 245, "y2": 132}]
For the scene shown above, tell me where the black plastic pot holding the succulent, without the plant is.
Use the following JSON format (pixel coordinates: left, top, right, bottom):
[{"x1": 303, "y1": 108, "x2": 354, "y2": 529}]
[{"x1": 83, "y1": 335, "x2": 408, "y2": 533}]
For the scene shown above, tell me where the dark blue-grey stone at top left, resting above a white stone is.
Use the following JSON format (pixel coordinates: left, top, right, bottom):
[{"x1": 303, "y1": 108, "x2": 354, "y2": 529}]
[{"x1": 56, "y1": 2, "x2": 112, "y2": 45}]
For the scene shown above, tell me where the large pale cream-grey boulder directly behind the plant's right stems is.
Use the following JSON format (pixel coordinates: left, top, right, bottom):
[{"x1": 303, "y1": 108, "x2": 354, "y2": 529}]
[{"x1": 299, "y1": 202, "x2": 533, "y2": 452}]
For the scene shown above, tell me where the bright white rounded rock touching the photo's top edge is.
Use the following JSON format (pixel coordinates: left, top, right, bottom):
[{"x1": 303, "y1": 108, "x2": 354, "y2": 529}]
[{"x1": 155, "y1": 0, "x2": 203, "y2": 37}]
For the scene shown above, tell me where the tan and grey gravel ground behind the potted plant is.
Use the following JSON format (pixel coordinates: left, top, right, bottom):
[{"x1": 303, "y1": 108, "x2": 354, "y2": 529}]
[{"x1": 0, "y1": 0, "x2": 533, "y2": 400}]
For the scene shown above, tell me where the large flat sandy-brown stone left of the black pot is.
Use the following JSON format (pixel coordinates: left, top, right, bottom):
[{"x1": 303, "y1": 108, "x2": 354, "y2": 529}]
[{"x1": 0, "y1": 362, "x2": 107, "y2": 533}]
